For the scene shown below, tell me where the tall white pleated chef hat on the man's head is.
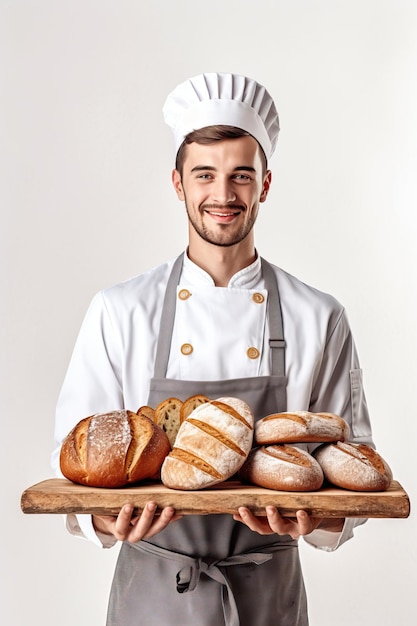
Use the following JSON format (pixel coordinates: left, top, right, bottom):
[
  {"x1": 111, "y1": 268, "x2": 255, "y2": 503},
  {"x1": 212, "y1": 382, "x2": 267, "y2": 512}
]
[{"x1": 163, "y1": 73, "x2": 279, "y2": 158}]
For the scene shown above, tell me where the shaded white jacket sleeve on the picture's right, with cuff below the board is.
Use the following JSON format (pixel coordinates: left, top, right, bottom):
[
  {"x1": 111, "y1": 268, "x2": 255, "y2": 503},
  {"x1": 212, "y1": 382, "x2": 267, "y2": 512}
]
[{"x1": 304, "y1": 311, "x2": 375, "y2": 552}]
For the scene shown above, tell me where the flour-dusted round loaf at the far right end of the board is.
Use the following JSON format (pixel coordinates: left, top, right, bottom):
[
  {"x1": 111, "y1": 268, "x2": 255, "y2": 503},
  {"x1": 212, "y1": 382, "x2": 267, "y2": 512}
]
[{"x1": 313, "y1": 441, "x2": 392, "y2": 491}]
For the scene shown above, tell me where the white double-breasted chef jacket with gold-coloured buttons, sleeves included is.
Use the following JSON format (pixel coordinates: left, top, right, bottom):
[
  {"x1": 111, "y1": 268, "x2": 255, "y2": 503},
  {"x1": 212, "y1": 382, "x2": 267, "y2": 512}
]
[{"x1": 52, "y1": 255, "x2": 373, "y2": 551}]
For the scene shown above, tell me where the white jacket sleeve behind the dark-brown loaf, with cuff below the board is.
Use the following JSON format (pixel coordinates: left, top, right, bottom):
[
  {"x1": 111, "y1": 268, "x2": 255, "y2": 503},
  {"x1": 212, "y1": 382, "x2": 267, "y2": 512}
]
[{"x1": 51, "y1": 293, "x2": 124, "y2": 547}]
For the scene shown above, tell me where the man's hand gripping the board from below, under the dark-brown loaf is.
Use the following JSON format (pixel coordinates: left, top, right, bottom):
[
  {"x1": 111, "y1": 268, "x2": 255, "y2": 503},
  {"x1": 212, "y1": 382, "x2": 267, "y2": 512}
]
[{"x1": 93, "y1": 502, "x2": 182, "y2": 543}]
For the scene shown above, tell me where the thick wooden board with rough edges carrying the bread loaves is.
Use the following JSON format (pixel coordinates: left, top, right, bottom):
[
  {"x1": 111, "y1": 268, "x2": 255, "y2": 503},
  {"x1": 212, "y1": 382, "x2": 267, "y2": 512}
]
[{"x1": 21, "y1": 478, "x2": 410, "y2": 518}]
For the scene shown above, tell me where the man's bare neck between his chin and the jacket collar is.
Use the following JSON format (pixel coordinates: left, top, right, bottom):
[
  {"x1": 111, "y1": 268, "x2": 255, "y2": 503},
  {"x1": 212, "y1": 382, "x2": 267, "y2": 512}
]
[{"x1": 187, "y1": 241, "x2": 256, "y2": 287}]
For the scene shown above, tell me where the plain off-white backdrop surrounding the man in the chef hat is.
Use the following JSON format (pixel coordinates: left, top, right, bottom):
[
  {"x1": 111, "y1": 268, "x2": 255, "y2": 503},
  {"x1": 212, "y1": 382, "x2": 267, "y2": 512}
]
[{"x1": 0, "y1": 0, "x2": 417, "y2": 626}]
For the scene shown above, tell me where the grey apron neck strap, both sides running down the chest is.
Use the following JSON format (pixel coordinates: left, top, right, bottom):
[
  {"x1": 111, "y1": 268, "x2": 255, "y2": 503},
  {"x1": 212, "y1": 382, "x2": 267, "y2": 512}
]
[{"x1": 154, "y1": 253, "x2": 285, "y2": 378}]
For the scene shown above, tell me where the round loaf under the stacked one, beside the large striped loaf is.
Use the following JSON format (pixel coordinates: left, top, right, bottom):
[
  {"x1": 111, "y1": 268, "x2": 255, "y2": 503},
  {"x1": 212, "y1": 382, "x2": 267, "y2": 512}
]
[{"x1": 239, "y1": 444, "x2": 323, "y2": 491}]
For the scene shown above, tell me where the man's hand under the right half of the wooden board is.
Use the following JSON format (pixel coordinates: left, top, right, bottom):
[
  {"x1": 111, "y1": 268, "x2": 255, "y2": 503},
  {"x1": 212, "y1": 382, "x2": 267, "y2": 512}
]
[{"x1": 233, "y1": 506, "x2": 344, "y2": 539}]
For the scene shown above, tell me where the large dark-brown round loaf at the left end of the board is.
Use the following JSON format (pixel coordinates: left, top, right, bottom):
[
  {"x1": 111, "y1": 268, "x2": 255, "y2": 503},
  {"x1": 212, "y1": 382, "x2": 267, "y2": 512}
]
[{"x1": 60, "y1": 410, "x2": 171, "y2": 487}]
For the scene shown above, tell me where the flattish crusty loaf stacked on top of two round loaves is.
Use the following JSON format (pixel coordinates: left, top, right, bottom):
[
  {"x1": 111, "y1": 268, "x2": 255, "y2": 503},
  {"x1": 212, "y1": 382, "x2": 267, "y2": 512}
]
[{"x1": 255, "y1": 411, "x2": 349, "y2": 445}]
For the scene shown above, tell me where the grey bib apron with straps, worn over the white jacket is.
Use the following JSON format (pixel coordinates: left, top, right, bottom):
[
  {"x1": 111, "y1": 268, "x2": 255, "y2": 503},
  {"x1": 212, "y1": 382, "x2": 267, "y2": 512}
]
[{"x1": 107, "y1": 255, "x2": 308, "y2": 626}]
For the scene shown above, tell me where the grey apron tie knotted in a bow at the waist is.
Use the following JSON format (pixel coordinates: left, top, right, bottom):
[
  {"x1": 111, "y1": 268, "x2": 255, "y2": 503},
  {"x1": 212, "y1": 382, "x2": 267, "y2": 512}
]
[{"x1": 131, "y1": 541, "x2": 272, "y2": 626}]
